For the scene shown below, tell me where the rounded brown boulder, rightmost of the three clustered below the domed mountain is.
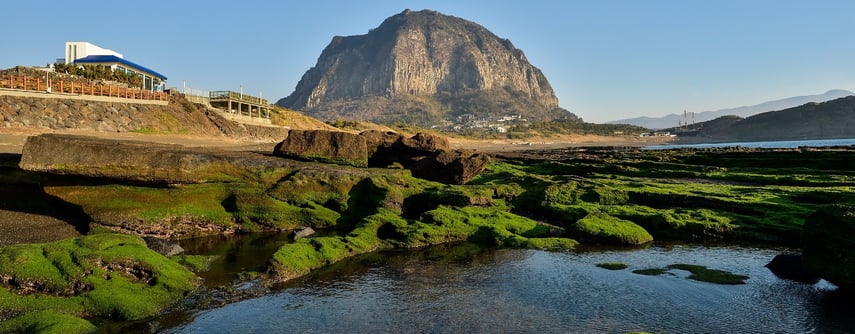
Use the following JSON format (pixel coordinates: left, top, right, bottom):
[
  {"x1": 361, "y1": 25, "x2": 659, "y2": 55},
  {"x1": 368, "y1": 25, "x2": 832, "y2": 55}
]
[{"x1": 410, "y1": 150, "x2": 490, "y2": 184}]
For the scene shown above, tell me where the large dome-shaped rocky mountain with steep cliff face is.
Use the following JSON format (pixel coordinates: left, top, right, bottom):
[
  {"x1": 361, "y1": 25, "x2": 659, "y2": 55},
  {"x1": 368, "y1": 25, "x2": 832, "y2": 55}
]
[{"x1": 277, "y1": 10, "x2": 578, "y2": 125}]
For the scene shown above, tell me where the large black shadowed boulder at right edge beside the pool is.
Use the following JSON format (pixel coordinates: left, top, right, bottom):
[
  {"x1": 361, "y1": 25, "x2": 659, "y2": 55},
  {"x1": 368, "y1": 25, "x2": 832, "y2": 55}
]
[{"x1": 802, "y1": 205, "x2": 855, "y2": 292}]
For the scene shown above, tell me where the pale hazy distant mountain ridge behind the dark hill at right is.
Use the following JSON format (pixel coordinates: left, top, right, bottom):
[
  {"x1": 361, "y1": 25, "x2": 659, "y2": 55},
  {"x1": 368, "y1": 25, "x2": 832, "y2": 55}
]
[{"x1": 607, "y1": 89, "x2": 855, "y2": 129}]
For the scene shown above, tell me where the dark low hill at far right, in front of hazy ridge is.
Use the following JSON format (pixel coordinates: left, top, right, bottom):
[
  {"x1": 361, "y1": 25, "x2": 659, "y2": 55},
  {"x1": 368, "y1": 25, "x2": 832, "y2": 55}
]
[{"x1": 669, "y1": 96, "x2": 855, "y2": 141}]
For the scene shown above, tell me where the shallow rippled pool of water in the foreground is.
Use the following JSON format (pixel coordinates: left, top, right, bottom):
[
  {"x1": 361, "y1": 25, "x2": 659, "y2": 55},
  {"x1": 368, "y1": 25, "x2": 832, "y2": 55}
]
[{"x1": 168, "y1": 245, "x2": 855, "y2": 333}]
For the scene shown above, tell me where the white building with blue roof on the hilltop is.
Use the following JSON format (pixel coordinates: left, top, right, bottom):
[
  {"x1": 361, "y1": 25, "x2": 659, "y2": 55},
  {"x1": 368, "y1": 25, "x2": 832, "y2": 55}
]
[{"x1": 57, "y1": 42, "x2": 166, "y2": 91}]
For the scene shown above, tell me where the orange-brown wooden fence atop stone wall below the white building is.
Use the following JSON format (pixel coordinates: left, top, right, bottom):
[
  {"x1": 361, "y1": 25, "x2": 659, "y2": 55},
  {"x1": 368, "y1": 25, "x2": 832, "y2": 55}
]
[{"x1": 0, "y1": 75, "x2": 169, "y2": 101}]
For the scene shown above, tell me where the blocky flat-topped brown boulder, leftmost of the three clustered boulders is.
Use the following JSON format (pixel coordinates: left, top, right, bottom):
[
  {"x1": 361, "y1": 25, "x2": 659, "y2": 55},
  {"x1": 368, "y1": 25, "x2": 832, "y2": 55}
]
[{"x1": 273, "y1": 130, "x2": 368, "y2": 167}]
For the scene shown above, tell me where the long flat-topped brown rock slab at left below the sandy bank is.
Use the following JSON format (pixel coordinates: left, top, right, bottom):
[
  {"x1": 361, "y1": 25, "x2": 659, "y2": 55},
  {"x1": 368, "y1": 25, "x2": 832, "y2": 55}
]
[{"x1": 19, "y1": 134, "x2": 298, "y2": 184}]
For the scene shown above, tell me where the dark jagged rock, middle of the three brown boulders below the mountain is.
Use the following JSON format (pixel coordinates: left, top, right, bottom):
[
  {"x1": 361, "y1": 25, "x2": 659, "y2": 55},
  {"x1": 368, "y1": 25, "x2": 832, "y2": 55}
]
[{"x1": 360, "y1": 130, "x2": 451, "y2": 167}]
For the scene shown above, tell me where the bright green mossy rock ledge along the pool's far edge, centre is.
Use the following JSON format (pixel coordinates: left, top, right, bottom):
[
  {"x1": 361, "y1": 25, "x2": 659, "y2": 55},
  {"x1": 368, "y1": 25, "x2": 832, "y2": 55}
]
[{"x1": 270, "y1": 206, "x2": 578, "y2": 281}]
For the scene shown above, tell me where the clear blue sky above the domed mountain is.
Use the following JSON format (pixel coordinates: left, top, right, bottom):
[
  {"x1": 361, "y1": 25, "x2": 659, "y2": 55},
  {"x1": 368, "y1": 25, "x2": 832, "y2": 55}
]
[{"x1": 0, "y1": 0, "x2": 855, "y2": 122}]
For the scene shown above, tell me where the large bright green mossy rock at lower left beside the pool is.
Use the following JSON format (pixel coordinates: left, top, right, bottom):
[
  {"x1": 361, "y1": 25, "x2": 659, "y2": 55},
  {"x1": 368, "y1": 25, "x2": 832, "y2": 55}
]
[{"x1": 0, "y1": 233, "x2": 199, "y2": 320}]
